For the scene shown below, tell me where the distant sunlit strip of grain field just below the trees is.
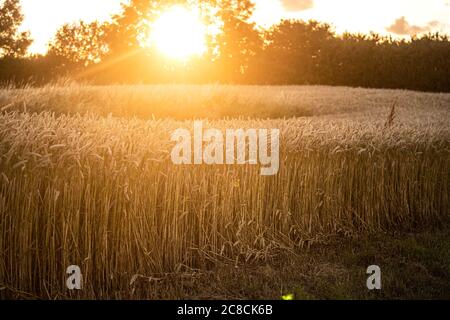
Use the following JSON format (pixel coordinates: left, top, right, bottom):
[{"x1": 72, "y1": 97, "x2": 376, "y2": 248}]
[{"x1": 0, "y1": 82, "x2": 450, "y2": 120}]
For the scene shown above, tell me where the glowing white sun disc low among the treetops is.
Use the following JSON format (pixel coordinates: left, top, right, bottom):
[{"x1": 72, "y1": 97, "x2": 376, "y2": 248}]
[{"x1": 149, "y1": 6, "x2": 207, "y2": 59}]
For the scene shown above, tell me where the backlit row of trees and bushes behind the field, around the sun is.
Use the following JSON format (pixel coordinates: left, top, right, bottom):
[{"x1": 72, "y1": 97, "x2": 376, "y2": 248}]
[{"x1": 0, "y1": 0, "x2": 450, "y2": 92}]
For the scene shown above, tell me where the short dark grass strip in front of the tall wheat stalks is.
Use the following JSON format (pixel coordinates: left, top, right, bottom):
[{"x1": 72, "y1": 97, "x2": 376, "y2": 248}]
[{"x1": 111, "y1": 224, "x2": 450, "y2": 300}]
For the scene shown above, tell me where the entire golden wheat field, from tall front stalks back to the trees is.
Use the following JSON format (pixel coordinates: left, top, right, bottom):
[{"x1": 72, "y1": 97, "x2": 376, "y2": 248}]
[{"x1": 0, "y1": 83, "x2": 450, "y2": 299}]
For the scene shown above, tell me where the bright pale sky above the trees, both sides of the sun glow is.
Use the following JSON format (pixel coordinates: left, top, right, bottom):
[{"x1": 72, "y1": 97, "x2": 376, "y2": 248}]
[{"x1": 21, "y1": 0, "x2": 450, "y2": 53}]
